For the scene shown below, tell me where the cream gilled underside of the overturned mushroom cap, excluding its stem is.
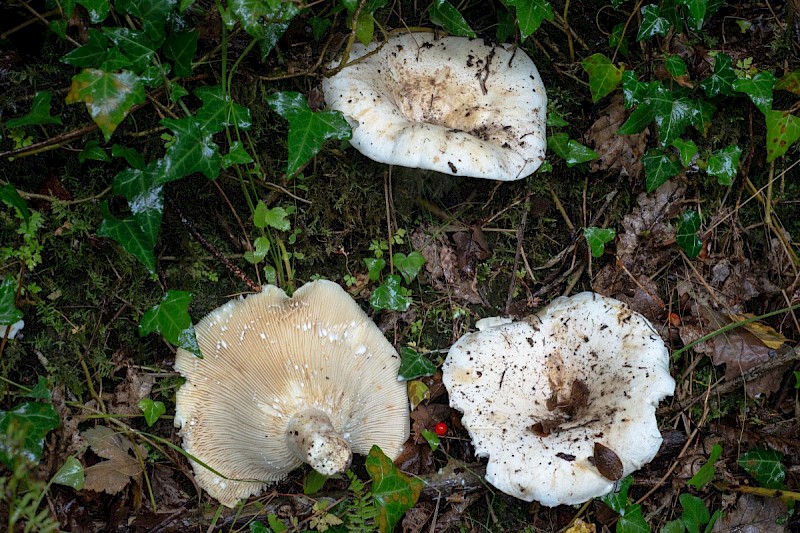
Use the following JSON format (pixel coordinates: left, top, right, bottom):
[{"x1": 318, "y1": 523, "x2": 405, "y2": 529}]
[{"x1": 175, "y1": 281, "x2": 409, "y2": 507}]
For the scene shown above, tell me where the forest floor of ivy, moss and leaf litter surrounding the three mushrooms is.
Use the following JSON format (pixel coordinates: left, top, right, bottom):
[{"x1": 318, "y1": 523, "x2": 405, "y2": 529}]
[{"x1": 0, "y1": 1, "x2": 800, "y2": 532}]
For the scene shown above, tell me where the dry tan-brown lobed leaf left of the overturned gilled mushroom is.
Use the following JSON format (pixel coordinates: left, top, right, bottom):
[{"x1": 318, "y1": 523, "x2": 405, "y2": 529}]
[{"x1": 81, "y1": 426, "x2": 147, "y2": 494}]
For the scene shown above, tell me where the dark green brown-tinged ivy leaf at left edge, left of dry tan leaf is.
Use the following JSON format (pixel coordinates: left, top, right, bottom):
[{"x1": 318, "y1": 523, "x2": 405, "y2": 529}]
[{"x1": 0, "y1": 402, "x2": 61, "y2": 470}]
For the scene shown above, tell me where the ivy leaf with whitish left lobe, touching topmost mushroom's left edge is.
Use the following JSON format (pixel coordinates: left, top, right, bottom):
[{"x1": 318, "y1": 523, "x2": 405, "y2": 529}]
[{"x1": 267, "y1": 92, "x2": 352, "y2": 176}]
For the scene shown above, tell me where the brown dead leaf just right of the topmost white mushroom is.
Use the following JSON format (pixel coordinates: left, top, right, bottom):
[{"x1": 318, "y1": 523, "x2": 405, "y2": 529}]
[{"x1": 587, "y1": 93, "x2": 648, "y2": 179}]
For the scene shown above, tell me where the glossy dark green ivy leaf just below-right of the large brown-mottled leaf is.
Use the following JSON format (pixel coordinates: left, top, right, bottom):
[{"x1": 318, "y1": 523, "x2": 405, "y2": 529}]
[{"x1": 161, "y1": 116, "x2": 220, "y2": 181}]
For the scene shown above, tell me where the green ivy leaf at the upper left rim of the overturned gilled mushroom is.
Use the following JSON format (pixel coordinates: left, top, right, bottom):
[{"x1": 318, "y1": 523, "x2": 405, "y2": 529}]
[{"x1": 139, "y1": 290, "x2": 202, "y2": 357}]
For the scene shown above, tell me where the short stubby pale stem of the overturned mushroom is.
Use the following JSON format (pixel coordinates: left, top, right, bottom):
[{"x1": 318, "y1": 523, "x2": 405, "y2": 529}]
[{"x1": 286, "y1": 408, "x2": 353, "y2": 476}]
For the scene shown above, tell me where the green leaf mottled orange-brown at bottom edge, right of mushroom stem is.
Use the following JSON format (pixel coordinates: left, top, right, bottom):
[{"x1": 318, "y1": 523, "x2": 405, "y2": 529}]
[{"x1": 364, "y1": 446, "x2": 422, "y2": 533}]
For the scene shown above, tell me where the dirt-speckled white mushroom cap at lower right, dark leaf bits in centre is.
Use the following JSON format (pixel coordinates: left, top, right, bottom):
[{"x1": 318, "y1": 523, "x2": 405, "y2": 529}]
[{"x1": 442, "y1": 292, "x2": 675, "y2": 507}]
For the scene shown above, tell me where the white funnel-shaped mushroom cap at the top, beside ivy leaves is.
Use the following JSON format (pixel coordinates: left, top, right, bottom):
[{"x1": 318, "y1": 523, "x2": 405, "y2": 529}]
[{"x1": 322, "y1": 33, "x2": 547, "y2": 181}]
